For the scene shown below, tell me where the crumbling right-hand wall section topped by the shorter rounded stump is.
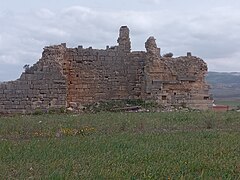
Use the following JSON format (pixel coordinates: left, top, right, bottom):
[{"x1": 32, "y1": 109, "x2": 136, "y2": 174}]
[{"x1": 145, "y1": 37, "x2": 211, "y2": 109}]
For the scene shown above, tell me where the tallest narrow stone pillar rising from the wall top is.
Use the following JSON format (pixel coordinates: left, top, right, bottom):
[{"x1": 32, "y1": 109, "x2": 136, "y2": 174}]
[{"x1": 117, "y1": 26, "x2": 131, "y2": 52}]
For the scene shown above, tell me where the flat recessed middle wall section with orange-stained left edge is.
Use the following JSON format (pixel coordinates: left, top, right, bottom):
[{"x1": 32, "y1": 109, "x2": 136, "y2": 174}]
[{"x1": 65, "y1": 46, "x2": 144, "y2": 107}]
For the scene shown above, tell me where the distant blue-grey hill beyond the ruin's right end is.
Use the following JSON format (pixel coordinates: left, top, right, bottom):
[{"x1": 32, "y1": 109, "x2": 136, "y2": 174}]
[{"x1": 206, "y1": 72, "x2": 240, "y2": 100}]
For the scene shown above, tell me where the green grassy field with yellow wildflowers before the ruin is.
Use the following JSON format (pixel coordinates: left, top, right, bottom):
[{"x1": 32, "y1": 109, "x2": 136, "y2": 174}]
[{"x1": 0, "y1": 112, "x2": 240, "y2": 179}]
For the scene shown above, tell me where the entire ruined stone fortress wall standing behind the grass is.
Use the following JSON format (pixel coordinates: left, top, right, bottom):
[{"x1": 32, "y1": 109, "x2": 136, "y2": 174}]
[{"x1": 0, "y1": 26, "x2": 211, "y2": 113}]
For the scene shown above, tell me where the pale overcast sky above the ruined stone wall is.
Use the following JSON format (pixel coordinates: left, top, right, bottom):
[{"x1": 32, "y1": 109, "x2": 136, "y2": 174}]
[{"x1": 0, "y1": 0, "x2": 240, "y2": 81}]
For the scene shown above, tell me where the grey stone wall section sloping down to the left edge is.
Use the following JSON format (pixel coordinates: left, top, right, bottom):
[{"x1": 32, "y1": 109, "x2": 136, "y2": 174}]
[{"x1": 0, "y1": 46, "x2": 67, "y2": 113}]
